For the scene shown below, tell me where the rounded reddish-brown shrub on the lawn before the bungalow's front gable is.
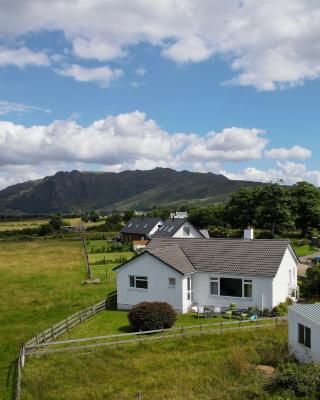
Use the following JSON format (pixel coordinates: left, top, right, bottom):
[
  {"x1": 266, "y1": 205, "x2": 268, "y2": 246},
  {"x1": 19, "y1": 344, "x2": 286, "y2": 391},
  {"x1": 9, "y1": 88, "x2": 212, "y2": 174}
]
[{"x1": 128, "y1": 301, "x2": 177, "y2": 331}]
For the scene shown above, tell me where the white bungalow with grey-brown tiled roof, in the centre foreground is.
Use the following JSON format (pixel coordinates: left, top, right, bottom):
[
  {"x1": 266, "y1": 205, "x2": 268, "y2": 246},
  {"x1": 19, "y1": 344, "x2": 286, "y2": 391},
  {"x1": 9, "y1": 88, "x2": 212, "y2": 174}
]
[{"x1": 115, "y1": 233, "x2": 298, "y2": 313}]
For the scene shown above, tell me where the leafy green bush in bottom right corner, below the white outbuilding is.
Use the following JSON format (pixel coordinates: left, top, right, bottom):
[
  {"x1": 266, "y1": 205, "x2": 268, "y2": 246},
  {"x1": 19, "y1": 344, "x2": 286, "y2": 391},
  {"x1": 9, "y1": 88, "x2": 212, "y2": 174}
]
[{"x1": 271, "y1": 362, "x2": 320, "y2": 400}]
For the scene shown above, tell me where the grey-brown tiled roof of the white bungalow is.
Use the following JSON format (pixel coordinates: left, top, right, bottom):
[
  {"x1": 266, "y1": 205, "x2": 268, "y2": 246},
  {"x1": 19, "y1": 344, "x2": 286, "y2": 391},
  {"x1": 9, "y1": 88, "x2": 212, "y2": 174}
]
[{"x1": 146, "y1": 238, "x2": 296, "y2": 276}]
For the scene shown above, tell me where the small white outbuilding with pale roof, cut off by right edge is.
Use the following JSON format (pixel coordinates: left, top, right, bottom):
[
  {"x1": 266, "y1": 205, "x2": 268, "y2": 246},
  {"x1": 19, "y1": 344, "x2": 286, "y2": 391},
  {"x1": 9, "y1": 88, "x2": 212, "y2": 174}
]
[{"x1": 288, "y1": 303, "x2": 320, "y2": 362}]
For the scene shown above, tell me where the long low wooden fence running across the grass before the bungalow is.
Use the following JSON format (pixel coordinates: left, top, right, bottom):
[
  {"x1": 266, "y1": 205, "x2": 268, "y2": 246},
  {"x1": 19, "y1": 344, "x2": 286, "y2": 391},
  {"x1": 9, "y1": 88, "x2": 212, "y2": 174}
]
[{"x1": 25, "y1": 317, "x2": 287, "y2": 356}]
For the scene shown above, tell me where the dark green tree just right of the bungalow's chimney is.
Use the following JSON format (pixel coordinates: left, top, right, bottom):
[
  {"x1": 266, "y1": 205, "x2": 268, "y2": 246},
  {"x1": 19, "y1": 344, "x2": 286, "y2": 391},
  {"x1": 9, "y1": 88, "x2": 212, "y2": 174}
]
[{"x1": 257, "y1": 182, "x2": 294, "y2": 236}]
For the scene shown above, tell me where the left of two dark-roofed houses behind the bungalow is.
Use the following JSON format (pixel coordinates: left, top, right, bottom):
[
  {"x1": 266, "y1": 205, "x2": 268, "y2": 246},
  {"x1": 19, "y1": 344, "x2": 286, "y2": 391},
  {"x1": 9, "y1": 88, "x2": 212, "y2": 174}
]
[{"x1": 120, "y1": 216, "x2": 163, "y2": 242}]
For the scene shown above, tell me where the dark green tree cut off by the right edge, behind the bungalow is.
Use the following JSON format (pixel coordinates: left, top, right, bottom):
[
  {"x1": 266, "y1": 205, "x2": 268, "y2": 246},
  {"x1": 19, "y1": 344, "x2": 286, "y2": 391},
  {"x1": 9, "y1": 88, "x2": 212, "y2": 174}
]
[{"x1": 291, "y1": 182, "x2": 320, "y2": 236}]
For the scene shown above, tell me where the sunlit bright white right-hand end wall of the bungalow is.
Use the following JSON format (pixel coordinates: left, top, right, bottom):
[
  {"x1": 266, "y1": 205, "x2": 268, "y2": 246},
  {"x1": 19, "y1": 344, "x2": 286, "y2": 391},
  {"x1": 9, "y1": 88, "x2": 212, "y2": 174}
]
[{"x1": 272, "y1": 247, "x2": 298, "y2": 307}]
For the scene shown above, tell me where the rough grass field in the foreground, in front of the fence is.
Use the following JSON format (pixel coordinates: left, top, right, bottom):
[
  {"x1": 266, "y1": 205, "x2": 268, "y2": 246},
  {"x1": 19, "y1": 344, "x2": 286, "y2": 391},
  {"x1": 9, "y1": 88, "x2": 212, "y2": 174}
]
[{"x1": 22, "y1": 327, "x2": 294, "y2": 400}]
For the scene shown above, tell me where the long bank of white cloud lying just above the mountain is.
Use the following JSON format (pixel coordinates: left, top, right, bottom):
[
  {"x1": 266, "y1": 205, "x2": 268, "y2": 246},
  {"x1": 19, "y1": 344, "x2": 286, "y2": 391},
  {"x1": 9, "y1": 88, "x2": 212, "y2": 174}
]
[{"x1": 0, "y1": 111, "x2": 320, "y2": 187}]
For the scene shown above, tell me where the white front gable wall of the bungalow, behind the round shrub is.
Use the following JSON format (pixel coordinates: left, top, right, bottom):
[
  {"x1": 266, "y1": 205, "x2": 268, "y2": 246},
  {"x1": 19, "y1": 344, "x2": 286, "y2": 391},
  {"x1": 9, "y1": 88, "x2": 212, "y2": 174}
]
[{"x1": 116, "y1": 253, "x2": 183, "y2": 312}]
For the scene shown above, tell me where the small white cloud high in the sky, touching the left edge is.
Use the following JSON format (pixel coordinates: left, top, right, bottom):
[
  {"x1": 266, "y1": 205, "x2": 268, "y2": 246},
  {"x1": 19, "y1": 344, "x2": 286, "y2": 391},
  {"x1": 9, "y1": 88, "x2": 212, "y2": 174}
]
[{"x1": 0, "y1": 46, "x2": 50, "y2": 68}]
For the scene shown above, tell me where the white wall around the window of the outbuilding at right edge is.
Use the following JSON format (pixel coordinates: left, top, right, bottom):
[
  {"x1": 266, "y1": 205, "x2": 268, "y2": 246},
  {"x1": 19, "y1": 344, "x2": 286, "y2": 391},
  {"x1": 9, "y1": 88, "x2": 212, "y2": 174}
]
[{"x1": 288, "y1": 307, "x2": 320, "y2": 363}]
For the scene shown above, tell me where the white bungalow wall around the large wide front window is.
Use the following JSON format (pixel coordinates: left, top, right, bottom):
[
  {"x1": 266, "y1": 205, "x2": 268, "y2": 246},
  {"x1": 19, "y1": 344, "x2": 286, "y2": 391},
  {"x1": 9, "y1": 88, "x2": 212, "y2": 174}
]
[{"x1": 193, "y1": 272, "x2": 272, "y2": 309}]
